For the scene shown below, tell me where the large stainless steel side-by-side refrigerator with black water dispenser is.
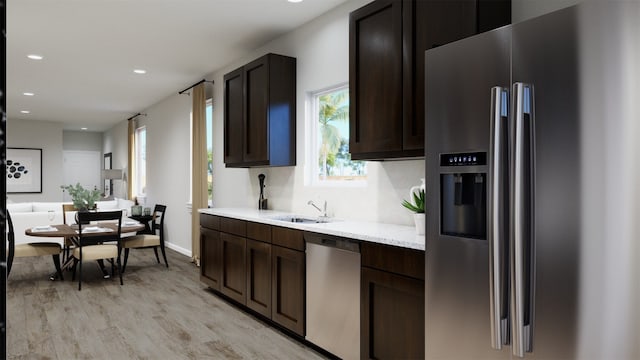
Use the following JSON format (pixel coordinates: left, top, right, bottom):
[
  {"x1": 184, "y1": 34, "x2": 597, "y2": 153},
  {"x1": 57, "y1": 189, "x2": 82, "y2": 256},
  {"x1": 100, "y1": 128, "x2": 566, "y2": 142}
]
[{"x1": 425, "y1": 6, "x2": 600, "y2": 359}]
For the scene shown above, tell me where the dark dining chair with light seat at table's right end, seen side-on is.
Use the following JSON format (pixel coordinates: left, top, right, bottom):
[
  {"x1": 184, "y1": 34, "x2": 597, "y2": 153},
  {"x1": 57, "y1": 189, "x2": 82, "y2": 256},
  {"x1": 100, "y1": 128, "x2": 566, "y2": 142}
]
[{"x1": 122, "y1": 204, "x2": 169, "y2": 272}]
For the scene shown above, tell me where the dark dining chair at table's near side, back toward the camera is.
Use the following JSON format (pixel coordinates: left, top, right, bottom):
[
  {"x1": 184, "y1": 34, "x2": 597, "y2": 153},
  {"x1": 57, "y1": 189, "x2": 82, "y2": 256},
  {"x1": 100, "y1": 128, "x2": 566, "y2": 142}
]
[{"x1": 72, "y1": 210, "x2": 123, "y2": 290}]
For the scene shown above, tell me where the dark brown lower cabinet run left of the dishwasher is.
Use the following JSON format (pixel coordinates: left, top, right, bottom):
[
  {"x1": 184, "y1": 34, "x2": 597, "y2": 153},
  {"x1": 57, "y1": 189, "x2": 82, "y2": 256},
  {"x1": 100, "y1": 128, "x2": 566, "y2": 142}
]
[{"x1": 200, "y1": 214, "x2": 305, "y2": 336}]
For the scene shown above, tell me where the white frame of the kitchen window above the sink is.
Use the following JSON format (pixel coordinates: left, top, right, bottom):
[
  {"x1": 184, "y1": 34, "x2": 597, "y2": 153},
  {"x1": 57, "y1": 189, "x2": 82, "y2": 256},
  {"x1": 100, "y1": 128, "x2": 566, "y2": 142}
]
[{"x1": 305, "y1": 82, "x2": 368, "y2": 188}]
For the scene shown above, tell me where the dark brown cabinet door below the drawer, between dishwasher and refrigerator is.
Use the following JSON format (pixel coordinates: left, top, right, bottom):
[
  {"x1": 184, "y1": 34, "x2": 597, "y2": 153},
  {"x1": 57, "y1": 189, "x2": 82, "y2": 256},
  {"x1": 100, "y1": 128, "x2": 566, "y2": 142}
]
[{"x1": 360, "y1": 267, "x2": 424, "y2": 359}]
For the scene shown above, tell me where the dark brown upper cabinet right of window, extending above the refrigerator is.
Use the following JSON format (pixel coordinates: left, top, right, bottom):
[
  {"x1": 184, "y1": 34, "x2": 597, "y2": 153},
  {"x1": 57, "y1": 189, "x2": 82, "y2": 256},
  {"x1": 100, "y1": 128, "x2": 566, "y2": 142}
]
[{"x1": 349, "y1": 0, "x2": 511, "y2": 160}]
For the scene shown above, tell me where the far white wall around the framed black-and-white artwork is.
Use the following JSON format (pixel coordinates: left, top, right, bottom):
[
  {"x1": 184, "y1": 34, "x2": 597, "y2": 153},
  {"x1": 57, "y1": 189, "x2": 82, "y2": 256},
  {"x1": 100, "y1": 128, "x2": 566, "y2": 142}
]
[{"x1": 7, "y1": 119, "x2": 63, "y2": 202}]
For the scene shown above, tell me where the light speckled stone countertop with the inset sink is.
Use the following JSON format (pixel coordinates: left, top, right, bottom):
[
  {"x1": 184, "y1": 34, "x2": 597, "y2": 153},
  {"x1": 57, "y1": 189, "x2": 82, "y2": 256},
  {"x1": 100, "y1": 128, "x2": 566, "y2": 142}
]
[{"x1": 198, "y1": 208, "x2": 425, "y2": 251}]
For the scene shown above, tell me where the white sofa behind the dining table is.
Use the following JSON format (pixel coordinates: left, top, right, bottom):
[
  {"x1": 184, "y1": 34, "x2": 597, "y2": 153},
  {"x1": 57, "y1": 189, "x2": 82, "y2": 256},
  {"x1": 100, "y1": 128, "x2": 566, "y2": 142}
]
[{"x1": 7, "y1": 198, "x2": 134, "y2": 244}]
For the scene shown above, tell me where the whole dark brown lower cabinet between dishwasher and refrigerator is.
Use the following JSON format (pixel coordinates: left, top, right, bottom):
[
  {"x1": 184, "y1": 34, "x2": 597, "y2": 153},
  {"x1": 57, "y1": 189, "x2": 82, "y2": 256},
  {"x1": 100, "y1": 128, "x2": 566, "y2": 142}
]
[{"x1": 360, "y1": 242, "x2": 424, "y2": 359}]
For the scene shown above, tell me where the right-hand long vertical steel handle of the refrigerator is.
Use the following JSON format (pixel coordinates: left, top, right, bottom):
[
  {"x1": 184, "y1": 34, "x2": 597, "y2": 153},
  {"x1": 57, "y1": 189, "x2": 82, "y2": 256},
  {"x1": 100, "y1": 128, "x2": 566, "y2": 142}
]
[{"x1": 510, "y1": 83, "x2": 535, "y2": 357}]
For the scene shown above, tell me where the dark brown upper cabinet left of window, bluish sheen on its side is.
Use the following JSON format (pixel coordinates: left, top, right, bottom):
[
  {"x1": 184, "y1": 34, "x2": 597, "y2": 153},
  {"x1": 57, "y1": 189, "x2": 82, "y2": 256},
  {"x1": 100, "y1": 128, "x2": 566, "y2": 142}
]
[{"x1": 224, "y1": 54, "x2": 296, "y2": 167}]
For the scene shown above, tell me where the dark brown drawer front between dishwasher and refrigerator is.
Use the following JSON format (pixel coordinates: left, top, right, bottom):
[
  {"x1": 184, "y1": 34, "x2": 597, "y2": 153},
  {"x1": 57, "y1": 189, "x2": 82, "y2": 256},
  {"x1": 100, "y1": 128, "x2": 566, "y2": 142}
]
[{"x1": 360, "y1": 242, "x2": 424, "y2": 280}]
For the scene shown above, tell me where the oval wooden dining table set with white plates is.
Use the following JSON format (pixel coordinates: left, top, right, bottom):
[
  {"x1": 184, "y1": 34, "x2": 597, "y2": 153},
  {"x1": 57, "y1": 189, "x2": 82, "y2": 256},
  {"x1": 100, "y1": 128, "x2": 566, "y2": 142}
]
[{"x1": 24, "y1": 219, "x2": 145, "y2": 280}]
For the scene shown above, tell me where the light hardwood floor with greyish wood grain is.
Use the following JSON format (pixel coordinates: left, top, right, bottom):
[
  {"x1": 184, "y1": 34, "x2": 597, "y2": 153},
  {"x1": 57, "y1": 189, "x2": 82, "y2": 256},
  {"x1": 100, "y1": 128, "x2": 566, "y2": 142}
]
[{"x1": 7, "y1": 249, "x2": 324, "y2": 360}]
